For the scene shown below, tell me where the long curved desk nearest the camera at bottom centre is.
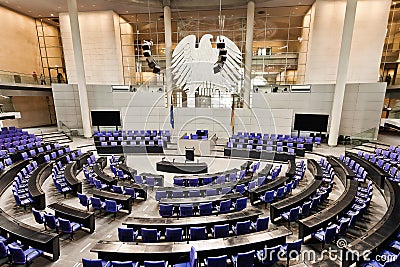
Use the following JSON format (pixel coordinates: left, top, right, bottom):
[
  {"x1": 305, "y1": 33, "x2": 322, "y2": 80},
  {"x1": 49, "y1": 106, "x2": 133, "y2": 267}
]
[{"x1": 90, "y1": 226, "x2": 291, "y2": 264}]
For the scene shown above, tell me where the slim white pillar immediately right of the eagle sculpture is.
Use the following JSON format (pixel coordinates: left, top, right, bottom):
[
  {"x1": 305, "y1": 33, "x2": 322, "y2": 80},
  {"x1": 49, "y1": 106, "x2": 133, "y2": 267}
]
[{"x1": 242, "y1": 0, "x2": 255, "y2": 108}]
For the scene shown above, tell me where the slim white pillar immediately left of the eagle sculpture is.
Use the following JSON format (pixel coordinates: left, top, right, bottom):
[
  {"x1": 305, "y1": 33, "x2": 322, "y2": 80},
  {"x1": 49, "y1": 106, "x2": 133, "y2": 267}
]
[{"x1": 164, "y1": 1, "x2": 172, "y2": 108}]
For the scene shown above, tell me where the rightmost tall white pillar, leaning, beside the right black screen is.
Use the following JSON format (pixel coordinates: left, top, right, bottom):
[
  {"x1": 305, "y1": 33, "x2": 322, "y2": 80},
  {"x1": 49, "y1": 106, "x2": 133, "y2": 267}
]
[{"x1": 328, "y1": 0, "x2": 357, "y2": 146}]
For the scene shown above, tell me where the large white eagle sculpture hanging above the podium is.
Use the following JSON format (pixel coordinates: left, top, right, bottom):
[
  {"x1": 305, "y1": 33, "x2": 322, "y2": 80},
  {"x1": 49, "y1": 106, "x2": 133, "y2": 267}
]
[{"x1": 171, "y1": 34, "x2": 242, "y2": 94}]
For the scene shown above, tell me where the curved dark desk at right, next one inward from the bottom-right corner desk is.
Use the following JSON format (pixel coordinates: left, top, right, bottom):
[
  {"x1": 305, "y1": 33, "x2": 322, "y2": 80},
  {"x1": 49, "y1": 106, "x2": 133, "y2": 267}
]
[{"x1": 299, "y1": 160, "x2": 358, "y2": 239}]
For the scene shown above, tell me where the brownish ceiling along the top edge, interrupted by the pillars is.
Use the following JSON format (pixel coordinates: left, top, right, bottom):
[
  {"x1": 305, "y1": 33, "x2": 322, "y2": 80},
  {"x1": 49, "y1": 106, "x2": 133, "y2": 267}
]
[{"x1": 0, "y1": 0, "x2": 315, "y2": 18}]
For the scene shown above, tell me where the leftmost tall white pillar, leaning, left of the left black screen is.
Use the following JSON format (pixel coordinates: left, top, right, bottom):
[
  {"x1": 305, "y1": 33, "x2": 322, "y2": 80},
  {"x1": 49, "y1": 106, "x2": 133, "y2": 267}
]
[{"x1": 68, "y1": 0, "x2": 92, "y2": 138}]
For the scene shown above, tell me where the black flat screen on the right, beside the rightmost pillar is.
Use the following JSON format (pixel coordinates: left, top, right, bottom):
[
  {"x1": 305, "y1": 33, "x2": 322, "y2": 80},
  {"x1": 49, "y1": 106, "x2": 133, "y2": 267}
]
[{"x1": 294, "y1": 114, "x2": 329, "y2": 132}]
